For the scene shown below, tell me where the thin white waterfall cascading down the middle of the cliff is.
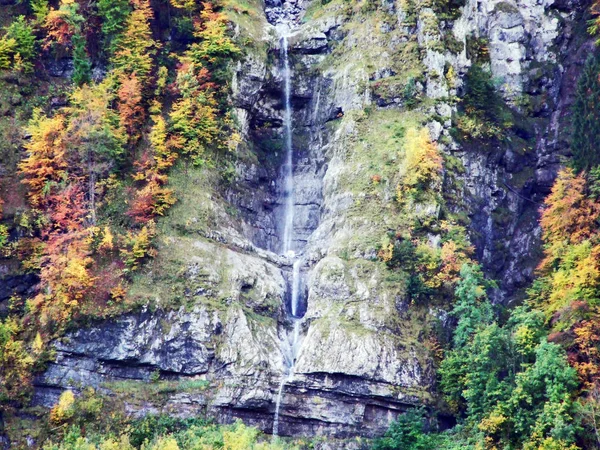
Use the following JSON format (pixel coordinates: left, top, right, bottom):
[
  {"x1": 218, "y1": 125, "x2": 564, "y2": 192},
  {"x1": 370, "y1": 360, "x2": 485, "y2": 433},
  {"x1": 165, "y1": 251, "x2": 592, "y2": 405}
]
[{"x1": 273, "y1": 25, "x2": 302, "y2": 439}]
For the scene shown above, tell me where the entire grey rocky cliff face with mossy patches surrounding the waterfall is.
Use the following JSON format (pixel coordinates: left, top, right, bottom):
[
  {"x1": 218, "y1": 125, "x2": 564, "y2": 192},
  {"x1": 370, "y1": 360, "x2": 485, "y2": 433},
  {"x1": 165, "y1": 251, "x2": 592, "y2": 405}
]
[{"x1": 30, "y1": 0, "x2": 586, "y2": 438}]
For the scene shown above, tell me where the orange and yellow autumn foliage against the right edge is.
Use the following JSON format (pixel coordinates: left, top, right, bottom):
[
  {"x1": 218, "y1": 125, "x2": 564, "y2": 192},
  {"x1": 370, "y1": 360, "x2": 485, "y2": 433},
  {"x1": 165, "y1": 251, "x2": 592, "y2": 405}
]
[{"x1": 537, "y1": 169, "x2": 600, "y2": 390}]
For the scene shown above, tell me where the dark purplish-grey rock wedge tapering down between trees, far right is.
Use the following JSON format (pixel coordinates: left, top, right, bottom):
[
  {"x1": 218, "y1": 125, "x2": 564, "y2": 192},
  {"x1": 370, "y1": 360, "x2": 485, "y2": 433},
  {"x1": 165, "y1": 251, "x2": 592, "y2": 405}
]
[{"x1": 440, "y1": 1, "x2": 591, "y2": 302}]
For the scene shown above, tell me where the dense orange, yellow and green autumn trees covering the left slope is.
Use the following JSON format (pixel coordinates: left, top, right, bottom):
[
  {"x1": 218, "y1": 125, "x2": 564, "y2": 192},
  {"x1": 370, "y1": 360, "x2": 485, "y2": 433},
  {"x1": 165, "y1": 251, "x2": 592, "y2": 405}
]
[{"x1": 0, "y1": 0, "x2": 239, "y2": 408}]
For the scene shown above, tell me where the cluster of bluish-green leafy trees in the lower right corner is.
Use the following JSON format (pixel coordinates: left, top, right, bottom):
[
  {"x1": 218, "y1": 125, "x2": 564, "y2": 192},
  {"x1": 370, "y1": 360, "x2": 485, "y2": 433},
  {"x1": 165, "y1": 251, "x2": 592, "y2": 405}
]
[{"x1": 439, "y1": 265, "x2": 579, "y2": 449}]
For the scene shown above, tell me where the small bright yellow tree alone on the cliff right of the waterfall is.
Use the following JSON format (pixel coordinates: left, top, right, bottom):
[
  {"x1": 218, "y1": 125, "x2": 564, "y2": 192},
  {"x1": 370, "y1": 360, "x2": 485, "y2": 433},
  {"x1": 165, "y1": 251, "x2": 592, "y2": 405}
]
[{"x1": 397, "y1": 128, "x2": 443, "y2": 199}]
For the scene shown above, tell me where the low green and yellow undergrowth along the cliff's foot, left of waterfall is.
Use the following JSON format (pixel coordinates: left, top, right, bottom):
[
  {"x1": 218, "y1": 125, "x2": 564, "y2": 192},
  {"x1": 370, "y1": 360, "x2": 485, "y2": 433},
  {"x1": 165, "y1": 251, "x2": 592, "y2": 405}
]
[{"x1": 5, "y1": 388, "x2": 300, "y2": 450}]
